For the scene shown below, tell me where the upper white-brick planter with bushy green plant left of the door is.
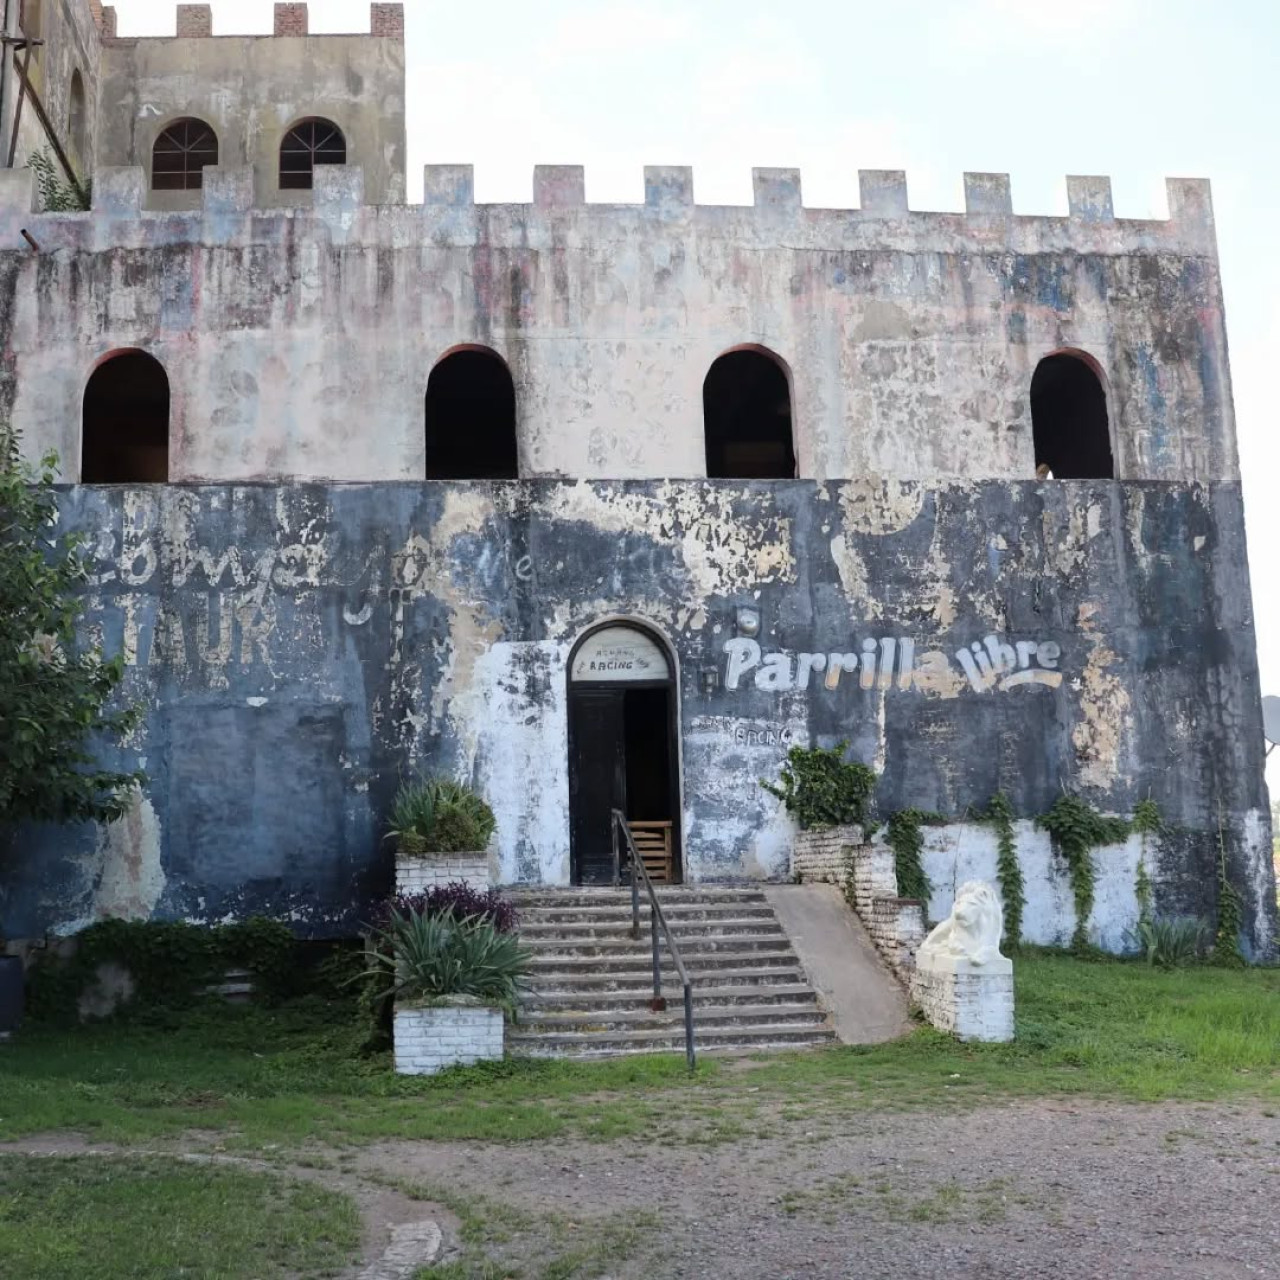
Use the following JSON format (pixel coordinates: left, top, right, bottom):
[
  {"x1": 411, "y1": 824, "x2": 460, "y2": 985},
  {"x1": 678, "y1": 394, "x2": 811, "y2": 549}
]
[{"x1": 388, "y1": 778, "x2": 497, "y2": 893}]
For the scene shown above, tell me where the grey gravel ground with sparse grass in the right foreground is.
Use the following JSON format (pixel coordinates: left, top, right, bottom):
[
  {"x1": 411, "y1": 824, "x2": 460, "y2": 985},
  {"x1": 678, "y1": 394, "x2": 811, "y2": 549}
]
[{"x1": 10, "y1": 1101, "x2": 1280, "y2": 1280}]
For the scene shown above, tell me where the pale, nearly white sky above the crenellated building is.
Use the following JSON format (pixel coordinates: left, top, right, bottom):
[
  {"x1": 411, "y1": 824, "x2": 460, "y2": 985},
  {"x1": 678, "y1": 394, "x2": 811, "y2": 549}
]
[{"x1": 115, "y1": 0, "x2": 1280, "y2": 787}]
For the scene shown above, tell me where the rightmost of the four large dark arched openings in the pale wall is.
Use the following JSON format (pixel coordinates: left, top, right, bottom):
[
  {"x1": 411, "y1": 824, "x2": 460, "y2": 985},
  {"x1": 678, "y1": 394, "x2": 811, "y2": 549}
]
[{"x1": 1032, "y1": 351, "x2": 1115, "y2": 480}]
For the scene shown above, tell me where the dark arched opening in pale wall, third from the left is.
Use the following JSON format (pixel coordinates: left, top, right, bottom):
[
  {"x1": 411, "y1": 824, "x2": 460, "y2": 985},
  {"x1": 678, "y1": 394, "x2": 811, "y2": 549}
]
[{"x1": 703, "y1": 347, "x2": 796, "y2": 480}]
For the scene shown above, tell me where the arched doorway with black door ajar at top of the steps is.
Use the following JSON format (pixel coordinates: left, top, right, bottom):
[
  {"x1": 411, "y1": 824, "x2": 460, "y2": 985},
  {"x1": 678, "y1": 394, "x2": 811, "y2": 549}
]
[{"x1": 568, "y1": 622, "x2": 681, "y2": 884}]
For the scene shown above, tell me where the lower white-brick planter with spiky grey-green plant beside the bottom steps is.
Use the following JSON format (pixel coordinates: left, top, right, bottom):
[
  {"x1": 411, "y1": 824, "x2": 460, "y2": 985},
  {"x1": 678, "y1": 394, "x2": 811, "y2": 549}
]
[{"x1": 367, "y1": 886, "x2": 530, "y2": 1075}]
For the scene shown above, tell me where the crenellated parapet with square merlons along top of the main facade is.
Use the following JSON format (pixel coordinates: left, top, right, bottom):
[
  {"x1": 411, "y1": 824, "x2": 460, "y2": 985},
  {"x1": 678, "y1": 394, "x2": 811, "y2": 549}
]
[{"x1": 0, "y1": 164, "x2": 1217, "y2": 259}]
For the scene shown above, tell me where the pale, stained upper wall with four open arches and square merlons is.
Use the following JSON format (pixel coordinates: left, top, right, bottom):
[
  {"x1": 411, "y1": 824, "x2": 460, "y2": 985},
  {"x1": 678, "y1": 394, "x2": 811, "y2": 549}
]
[{"x1": 0, "y1": 168, "x2": 1238, "y2": 484}]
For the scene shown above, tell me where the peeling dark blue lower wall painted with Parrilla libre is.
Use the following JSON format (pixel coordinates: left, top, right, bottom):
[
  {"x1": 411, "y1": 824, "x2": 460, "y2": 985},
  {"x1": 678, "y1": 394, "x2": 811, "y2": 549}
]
[{"x1": 0, "y1": 481, "x2": 1275, "y2": 951}]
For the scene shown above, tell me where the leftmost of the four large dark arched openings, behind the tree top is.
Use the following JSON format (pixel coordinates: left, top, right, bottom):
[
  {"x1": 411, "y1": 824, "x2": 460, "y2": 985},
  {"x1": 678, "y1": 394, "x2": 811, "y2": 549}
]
[{"x1": 81, "y1": 351, "x2": 169, "y2": 484}]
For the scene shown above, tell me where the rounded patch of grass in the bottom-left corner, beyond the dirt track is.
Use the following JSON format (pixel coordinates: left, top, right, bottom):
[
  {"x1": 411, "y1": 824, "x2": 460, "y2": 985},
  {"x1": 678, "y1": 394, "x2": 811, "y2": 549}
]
[{"x1": 0, "y1": 1156, "x2": 361, "y2": 1280}]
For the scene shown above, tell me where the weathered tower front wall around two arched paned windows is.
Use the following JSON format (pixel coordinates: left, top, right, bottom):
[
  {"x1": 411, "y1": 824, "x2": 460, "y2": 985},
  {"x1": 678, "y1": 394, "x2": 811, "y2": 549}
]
[{"x1": 99, "y1": 5, "x2": 404, "y2": 209}]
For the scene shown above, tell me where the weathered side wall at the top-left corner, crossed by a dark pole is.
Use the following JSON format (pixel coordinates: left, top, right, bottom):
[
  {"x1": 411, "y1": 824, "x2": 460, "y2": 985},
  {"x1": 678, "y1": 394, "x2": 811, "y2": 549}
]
[{"x1": 0, "y1": 0, "x2": 101, "y2": 178}]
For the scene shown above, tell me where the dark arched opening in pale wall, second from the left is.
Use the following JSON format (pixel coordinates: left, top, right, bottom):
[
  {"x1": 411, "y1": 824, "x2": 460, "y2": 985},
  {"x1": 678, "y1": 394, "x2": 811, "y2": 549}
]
[{"x1": 426, "y1": 347, "x2": 520, "y2": 480}]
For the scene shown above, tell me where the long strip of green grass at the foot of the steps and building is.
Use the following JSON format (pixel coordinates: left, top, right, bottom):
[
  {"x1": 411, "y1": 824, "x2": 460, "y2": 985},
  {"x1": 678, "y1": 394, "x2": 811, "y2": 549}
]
[{"x1": 0, "y1": 954, "x2": 1280, "y2": 1152}]
